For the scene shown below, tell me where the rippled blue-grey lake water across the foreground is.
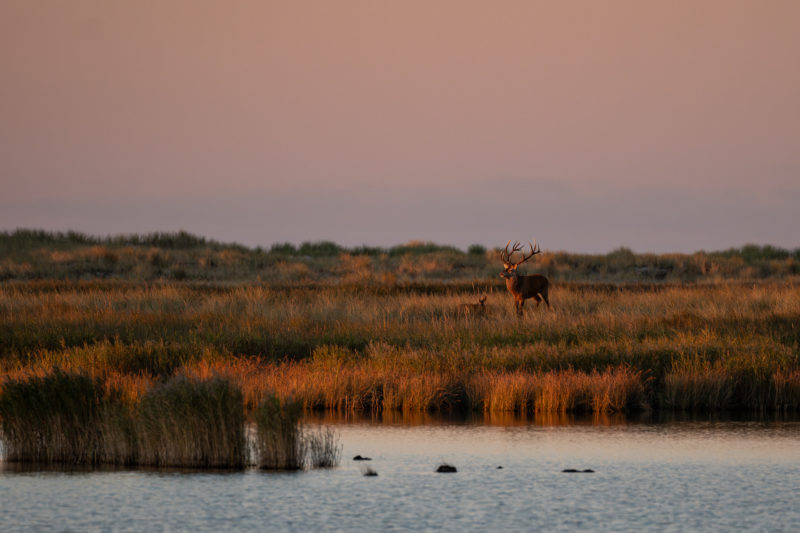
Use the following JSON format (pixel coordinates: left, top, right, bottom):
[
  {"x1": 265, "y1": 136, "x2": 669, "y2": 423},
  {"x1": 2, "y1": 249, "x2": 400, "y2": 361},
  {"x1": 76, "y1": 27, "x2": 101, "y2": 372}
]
[{"x1": 0, "y1": 418, "x2": 800, "y2": 532}]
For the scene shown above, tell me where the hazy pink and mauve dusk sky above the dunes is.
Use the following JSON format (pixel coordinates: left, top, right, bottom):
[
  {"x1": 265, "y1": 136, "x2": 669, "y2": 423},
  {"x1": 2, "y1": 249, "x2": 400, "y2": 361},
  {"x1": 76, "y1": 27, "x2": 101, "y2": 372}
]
[{"x1": 0, "y1": 0, "x2": 800, "y2": 252}]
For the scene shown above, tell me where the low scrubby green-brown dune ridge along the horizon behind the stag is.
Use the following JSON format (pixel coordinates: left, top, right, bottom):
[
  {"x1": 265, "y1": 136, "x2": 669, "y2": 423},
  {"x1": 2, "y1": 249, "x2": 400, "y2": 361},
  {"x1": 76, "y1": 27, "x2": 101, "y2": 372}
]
[{"x1": 0, "y1": 229, "x2": 800, "y2": 285}]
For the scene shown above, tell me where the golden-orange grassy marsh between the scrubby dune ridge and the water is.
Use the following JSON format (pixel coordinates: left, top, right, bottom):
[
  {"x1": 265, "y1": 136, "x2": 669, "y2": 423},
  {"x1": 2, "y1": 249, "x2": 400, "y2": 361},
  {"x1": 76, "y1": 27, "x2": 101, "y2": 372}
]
[{"x1": 0, "y1": 272, "x2": 800, "y2": 413}]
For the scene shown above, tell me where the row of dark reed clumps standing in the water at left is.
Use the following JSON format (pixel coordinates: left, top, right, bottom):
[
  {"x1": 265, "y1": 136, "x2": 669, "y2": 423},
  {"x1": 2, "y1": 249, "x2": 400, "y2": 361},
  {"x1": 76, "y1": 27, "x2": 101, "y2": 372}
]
[{"x1": 0, "y1": 370, "x2": 341, "y2": 470}]
